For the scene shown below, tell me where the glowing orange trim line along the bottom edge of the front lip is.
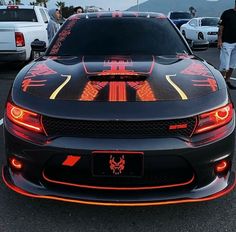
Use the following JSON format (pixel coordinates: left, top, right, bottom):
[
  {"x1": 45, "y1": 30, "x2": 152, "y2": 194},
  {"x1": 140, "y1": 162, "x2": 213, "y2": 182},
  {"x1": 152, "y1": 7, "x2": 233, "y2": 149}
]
[{"x1": 2, "y1": 168, "x2": 236, "y2": 206}]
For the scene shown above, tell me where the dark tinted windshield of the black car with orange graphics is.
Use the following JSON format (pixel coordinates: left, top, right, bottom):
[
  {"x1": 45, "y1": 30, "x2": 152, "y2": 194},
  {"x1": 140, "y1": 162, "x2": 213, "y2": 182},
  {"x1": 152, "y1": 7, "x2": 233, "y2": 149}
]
[{"x1": 47, "y1": 17, "x2": 189, "y2": 56}]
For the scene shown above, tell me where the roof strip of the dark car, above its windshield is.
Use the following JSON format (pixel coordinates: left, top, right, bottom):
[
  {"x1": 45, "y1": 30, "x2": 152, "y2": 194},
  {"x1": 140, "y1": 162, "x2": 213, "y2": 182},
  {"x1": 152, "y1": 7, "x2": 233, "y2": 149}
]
[{"x1": 69, "y1": 11, "x2": 167, "y2": 19}]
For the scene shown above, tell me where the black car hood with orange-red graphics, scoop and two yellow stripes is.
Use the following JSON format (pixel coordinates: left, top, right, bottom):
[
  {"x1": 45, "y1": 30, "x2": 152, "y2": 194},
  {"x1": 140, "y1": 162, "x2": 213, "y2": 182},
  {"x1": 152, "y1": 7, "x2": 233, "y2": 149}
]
[{"x1": 17, "y1": 54, "x2": 218, "y2": 102}]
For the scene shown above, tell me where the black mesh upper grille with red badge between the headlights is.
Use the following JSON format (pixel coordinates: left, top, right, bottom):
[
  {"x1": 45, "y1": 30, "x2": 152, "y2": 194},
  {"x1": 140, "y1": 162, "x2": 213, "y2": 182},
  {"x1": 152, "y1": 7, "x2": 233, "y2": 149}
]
[{"x1": 42, "y1": 116, "x2": 197, "y2": 138}]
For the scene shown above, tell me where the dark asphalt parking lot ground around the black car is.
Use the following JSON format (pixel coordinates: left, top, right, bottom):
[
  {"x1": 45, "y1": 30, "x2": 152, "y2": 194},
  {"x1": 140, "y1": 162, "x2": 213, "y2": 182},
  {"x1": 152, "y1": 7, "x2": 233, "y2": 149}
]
[{"x1": 0, "y1": 48, "x2": 236, "y2": 232}]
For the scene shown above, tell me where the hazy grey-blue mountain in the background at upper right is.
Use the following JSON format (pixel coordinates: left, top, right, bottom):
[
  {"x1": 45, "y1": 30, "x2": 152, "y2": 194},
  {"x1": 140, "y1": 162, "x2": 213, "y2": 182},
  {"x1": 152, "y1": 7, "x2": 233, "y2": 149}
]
[{"x1": 128, "y1": 0, "x2": 234, "y2": 17}]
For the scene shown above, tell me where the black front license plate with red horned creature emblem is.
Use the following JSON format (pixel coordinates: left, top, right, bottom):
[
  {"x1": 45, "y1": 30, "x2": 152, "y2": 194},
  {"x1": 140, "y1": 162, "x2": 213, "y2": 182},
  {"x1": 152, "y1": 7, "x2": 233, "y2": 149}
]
[{"x1": 92, "y1": 151, "x2": 143, "y2": 177}]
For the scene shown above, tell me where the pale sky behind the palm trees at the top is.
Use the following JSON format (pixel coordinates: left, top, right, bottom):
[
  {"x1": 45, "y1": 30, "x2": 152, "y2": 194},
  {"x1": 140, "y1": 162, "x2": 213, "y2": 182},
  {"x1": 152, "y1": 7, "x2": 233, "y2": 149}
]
[{"x1": 21, "y1": 0, "x2": 148, "y2": 10}]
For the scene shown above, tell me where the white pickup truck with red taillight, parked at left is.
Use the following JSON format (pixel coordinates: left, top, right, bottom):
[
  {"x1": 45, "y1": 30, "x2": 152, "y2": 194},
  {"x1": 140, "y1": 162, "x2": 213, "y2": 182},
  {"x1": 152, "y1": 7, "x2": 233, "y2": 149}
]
[{"x1": 0, "y1": 5, "x2": 49, "y2": 61}]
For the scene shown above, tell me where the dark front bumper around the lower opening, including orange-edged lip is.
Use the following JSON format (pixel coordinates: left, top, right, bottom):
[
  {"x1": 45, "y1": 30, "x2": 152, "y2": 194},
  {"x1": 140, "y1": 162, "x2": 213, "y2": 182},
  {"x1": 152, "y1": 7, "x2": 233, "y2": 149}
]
[{"x1": 2, "y1": 118, "x2": 236, "y2": 206}]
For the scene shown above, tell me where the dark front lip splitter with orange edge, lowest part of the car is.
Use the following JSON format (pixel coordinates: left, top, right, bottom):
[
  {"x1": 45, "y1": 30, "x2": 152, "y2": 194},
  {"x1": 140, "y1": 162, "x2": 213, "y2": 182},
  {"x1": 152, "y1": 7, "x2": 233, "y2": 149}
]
[{"x1": 2, "y1": 167, "x2": 236, "y2": 206}]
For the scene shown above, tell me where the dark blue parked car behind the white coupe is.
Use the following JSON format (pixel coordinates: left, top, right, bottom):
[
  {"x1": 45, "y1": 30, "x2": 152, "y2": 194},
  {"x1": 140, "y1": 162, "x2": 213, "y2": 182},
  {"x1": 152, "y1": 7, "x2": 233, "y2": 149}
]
[{"x1": 167, "y1": 11, "x2": 192, "y2": 28}]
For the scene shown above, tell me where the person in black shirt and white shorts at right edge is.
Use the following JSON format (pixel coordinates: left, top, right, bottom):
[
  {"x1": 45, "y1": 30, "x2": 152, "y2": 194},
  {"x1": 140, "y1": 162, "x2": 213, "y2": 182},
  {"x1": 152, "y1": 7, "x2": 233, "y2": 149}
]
[{"x1": 217, "y1": 0, "x2": 236, "y2": 89}]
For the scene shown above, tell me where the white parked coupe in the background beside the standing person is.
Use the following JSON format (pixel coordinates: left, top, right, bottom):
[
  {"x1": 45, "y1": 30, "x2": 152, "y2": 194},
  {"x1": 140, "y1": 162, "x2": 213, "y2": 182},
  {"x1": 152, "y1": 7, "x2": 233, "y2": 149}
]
[{"x1": 180, "y1": 17, "x2": 220, "y2": 43}]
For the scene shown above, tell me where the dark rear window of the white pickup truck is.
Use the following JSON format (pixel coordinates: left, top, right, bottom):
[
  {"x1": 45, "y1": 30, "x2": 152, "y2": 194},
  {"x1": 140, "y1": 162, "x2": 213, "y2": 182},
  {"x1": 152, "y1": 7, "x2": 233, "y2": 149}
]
[{"x1": 0, "y1": 9, "x2": 37, "y2": 22}]
